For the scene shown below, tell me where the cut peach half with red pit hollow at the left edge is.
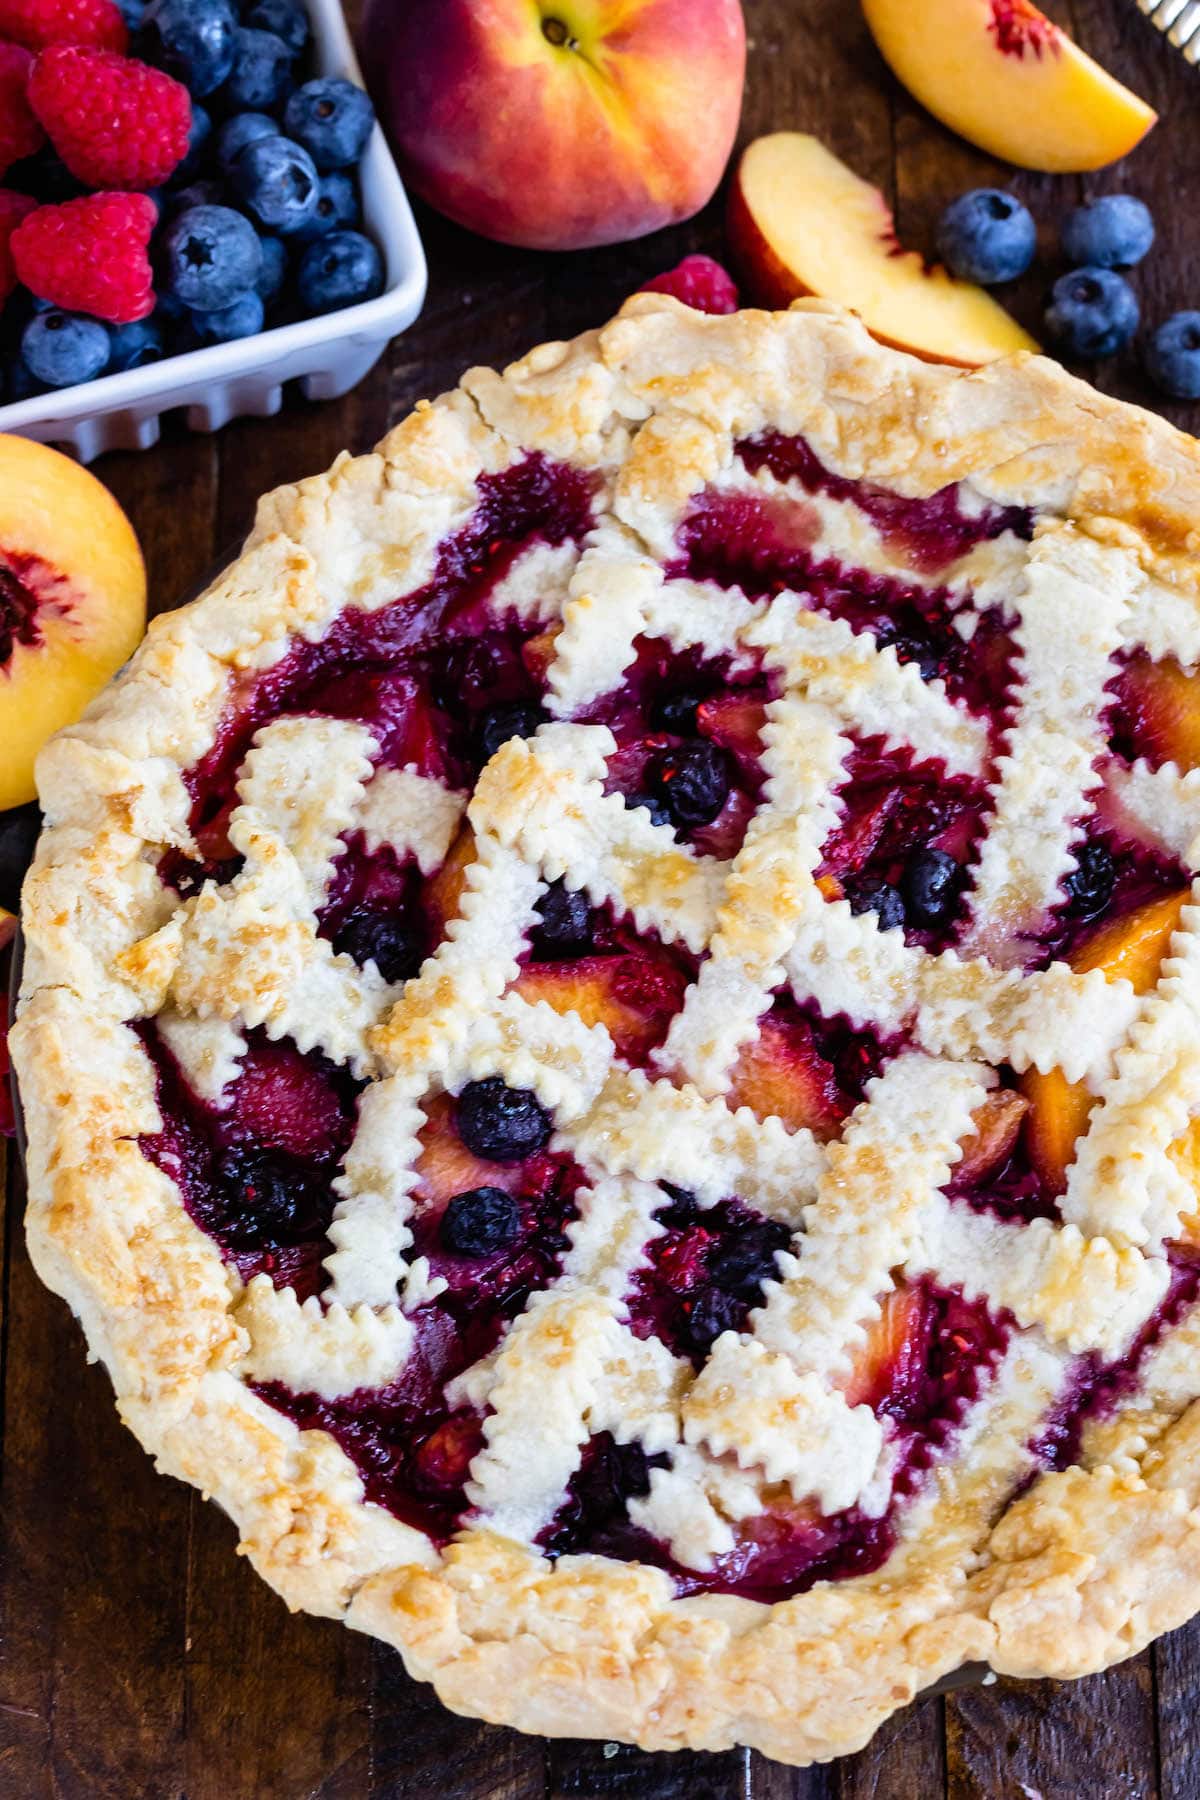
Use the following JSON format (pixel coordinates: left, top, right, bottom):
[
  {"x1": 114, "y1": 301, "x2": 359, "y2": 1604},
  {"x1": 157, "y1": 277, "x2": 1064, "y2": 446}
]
[{"x1": 0, "y1": 436, "x2": 146, "y2": 812}]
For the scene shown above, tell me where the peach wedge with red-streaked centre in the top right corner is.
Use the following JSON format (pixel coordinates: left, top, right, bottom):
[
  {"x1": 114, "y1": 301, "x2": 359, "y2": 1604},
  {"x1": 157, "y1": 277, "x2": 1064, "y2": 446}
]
[{"x1": 862, "y1": 0, "x2": 1157, "y2": 175}]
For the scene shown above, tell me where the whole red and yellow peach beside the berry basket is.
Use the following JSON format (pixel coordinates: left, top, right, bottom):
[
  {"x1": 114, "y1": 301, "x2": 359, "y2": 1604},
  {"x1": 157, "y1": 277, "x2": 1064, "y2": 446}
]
[{"x1": 362, "y1": 0, "x2": 745, "y2": 250}]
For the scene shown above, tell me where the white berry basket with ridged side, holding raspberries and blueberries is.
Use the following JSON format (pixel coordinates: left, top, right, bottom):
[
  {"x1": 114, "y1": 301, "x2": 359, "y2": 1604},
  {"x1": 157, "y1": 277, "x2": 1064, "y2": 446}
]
[{"x1": 0, "y1": 0, "x2": 426, "y2": 463}]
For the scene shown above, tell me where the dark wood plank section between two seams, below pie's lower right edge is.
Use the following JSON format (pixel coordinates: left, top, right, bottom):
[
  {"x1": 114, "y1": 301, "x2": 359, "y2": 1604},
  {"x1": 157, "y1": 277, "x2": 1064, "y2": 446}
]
[{"x1": 946, "y1": 1656, "x2": 1159, "y2": 1800}]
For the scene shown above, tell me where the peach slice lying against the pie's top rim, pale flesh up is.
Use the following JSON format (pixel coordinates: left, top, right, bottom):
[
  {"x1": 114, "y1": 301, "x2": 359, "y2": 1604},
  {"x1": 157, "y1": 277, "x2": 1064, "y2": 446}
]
[{"x1": 729, "y1": 131, "x2": 1038, "y2": 367}]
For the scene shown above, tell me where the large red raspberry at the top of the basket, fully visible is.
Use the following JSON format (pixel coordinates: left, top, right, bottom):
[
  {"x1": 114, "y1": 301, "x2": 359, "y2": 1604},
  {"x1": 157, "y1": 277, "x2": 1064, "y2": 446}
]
[{"x1": 29, "y1": 43, "x2": 193, "y2": 189}]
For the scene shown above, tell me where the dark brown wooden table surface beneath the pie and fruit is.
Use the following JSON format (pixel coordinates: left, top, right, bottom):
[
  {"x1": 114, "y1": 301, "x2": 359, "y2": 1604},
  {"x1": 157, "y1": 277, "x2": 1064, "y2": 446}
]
[{"x1": 0, "y1": 0, "x2": 1200, "y2": 1800}]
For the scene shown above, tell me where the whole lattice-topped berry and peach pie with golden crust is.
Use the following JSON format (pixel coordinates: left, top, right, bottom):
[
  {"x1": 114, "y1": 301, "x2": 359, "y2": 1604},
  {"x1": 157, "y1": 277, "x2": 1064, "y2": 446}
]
[{"x1": 13, "y1": 293, "x2": 1200, "y2": 1762}]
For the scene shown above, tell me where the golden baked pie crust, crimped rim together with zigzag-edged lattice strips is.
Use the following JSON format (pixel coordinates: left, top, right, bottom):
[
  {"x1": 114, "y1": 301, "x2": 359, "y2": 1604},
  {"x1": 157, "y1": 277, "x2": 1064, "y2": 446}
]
[{"x1": 13, "y1": 295, "x2": 1200, "y2": 1764}]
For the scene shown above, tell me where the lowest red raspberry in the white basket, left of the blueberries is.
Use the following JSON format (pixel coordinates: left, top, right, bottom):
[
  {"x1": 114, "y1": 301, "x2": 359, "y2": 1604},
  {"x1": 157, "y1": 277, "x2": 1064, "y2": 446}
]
[{"x1": 11, "y1": 194, "x2": 158, "y2": 326}]
